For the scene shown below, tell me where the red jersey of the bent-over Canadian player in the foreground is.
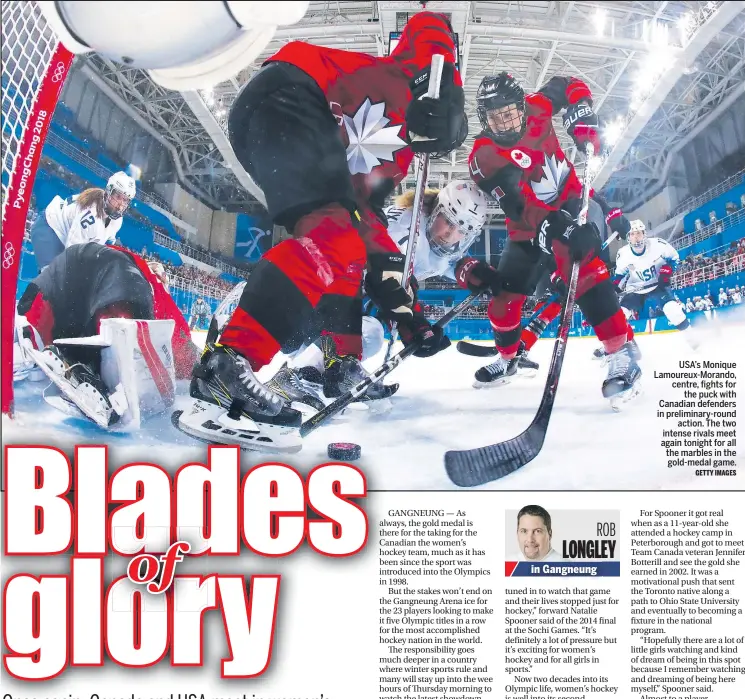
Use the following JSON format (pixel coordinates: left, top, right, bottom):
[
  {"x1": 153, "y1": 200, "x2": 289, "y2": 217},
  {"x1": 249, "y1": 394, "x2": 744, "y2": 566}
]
[{"x1": 267, "y1": 12, "x2": 460, "y2": 252}]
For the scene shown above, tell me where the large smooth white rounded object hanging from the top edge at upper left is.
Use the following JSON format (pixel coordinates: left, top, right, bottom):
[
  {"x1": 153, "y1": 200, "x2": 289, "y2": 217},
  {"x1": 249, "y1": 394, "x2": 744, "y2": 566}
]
[{"x1": 37, "y1": 0, "x2": 308, "y2": 90}]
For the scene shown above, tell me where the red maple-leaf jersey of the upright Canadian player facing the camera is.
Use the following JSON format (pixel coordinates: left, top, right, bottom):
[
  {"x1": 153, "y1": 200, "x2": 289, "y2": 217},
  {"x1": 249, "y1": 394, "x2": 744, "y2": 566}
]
[{"x1": 468, "y1": 78, "x2": 590, "y2": 240}]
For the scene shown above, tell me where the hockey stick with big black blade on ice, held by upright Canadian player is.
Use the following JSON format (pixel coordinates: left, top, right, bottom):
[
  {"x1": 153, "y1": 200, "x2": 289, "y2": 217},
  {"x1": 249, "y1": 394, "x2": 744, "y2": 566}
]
[{"x1": 445, "y1": 144, "x2": 593, "y2": 488}]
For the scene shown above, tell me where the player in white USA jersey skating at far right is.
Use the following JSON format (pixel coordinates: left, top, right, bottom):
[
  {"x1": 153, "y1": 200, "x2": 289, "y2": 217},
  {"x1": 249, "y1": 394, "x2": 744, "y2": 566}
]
[{"x1": 595, "y1": 220, "x2": 690, "y2": 358}]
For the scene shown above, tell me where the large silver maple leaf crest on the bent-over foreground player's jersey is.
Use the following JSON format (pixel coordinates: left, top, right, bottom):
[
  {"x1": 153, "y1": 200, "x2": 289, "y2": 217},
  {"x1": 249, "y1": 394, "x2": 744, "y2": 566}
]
[{"x1": 342, "y1": 97, "x2": 407, "y2": 175}]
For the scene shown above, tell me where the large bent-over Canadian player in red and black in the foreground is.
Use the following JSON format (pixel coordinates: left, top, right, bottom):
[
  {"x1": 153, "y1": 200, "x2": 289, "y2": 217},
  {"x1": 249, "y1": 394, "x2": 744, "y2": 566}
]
[{"x1": 175, "y1": 12, "x2": 468, "y2": 451}]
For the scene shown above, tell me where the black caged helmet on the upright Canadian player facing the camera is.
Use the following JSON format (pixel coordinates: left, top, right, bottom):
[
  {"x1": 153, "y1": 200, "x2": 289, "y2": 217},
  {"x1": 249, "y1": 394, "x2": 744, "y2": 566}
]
[{"x1": 476, "y1": 72, "x2": 527, "y2": 148}]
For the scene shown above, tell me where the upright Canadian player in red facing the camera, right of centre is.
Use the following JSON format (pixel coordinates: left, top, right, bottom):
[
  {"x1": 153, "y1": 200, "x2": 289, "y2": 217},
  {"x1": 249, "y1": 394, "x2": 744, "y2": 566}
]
[{"x1": 458, "y1": 73, "x2": 641, "y2": 405}]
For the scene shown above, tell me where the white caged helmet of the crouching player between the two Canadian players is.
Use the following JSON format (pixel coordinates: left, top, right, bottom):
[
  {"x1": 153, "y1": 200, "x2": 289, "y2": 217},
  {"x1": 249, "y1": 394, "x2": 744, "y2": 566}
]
[{"x1": 427, "y1": 180, "x2": 488, "y2": 258}]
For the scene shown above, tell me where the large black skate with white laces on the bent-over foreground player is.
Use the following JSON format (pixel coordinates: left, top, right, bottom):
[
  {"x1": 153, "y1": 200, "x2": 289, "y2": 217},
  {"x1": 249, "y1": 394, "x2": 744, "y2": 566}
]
[{"x1": 171, "y1": 345, "x2": 302, "y2": 453}]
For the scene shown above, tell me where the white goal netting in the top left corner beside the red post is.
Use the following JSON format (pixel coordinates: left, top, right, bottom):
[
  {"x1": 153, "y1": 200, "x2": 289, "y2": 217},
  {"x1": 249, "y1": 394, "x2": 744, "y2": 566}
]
[{"x1": 2, "y1": 0, "x2": 57, "y2": 221}]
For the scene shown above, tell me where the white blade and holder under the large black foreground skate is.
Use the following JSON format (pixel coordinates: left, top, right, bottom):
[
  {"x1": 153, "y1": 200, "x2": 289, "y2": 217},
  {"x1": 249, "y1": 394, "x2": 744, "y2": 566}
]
[{"x1": 171, "y1": 400, "x2": 303, "y2": 454}]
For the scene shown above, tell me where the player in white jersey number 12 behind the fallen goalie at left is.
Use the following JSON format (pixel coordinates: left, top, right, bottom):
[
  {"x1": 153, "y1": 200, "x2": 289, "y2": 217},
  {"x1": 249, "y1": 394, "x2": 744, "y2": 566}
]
[{"x1": 31, "y1": 172, "x2": 137, "y2": 271}]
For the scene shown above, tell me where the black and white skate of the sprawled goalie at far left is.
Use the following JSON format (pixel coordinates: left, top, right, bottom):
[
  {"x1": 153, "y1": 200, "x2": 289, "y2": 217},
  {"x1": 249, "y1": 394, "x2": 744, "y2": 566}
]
[{"x1": 27, "y1": 345, "x2": 127, "y2": 429}]
